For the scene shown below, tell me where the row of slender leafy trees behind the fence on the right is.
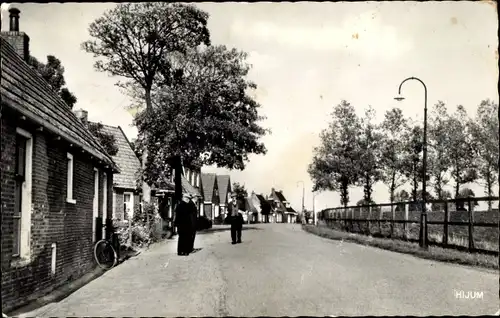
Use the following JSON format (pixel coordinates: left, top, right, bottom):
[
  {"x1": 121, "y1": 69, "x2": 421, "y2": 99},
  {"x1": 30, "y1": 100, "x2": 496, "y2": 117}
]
[{"x1": 308, "y1": 100, "x2": 499, "y2": 209}]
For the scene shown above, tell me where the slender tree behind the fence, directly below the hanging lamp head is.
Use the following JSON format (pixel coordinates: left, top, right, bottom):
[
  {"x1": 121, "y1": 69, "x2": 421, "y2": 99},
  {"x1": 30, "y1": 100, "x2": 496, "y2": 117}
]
[{"x1": 380, "y1": 108, "x2": 408, "y2": 203}]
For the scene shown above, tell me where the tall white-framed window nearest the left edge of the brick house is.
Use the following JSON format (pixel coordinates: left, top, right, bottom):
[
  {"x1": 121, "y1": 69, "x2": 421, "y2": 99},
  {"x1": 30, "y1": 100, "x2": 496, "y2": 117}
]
[{"x1": 12, "y1": 128, "x2": 33, "y2": 259}]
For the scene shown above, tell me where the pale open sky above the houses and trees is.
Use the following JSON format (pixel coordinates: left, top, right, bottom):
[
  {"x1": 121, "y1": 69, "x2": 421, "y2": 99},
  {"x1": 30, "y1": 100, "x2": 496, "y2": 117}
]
[{"x1": 2, "y1": 1, "x2": 499, "y2": 210}]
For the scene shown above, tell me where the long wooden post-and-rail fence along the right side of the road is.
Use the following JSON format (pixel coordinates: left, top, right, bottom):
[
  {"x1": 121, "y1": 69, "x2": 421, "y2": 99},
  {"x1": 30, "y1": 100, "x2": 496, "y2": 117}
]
[{"x1": 319, "y1": 197, "x2": 499, "y2": 255}]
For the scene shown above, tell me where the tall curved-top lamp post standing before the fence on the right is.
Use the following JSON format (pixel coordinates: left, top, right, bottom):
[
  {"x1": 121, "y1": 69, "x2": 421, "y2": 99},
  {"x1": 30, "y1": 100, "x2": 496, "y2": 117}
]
[{"x1": 394, "y1": 77, "x2": 427, "y2": 248}]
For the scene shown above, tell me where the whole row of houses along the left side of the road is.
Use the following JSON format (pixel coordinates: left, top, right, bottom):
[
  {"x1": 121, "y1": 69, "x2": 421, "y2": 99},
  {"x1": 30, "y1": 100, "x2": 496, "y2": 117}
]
[{"x1": 0, "y1": 8, "x2": 294, "y2": 312}]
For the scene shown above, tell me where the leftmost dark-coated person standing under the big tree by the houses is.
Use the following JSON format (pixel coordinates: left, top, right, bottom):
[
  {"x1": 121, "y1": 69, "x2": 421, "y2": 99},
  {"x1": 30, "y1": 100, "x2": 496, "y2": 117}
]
[{"x1": 174, "y1": 193, "x2": 194, "y2": 256}]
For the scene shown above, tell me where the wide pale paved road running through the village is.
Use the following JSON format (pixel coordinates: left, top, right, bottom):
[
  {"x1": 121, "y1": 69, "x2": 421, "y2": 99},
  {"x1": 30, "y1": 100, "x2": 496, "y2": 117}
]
[{"x1": 38, "y1": 224, "x2": 499, "y2": 317}]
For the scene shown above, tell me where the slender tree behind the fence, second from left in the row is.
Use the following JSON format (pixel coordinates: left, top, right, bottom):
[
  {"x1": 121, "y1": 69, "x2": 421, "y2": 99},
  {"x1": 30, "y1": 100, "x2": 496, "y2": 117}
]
[{"x1": 356, "y1": 106, "x2": 382, "y2": 202}]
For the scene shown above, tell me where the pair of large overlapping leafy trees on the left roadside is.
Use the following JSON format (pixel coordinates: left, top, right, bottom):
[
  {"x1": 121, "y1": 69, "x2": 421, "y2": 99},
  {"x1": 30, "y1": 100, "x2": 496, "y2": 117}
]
[{"x1": 82, "y1": 2, "x2": 268, "y2": 209}]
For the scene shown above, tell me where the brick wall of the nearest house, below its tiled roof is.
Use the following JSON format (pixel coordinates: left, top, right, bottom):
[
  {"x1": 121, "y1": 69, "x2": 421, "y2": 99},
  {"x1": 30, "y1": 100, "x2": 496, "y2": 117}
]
[{"x1": 1, "y1": 114, "x2": 113, "y2": 312}]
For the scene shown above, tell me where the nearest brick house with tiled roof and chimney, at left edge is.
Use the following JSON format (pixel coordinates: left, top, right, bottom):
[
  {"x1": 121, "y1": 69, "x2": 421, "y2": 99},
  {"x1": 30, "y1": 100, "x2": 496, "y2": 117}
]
[{"x1": 0, "y1": 8, "x2": 119, "y2": 312}]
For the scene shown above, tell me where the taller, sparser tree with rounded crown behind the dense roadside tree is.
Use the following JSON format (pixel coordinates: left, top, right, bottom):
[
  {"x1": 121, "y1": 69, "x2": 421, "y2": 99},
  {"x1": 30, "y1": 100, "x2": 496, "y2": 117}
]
[{"x1": 82, "y1": 2, "x2": 210, "y2": 206}]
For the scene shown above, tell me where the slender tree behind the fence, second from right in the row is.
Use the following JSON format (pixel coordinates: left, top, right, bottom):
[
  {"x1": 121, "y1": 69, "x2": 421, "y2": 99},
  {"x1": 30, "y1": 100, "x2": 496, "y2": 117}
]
[{"x1": 447, "y1": 105, "x2": 478, "y2": 198}]
